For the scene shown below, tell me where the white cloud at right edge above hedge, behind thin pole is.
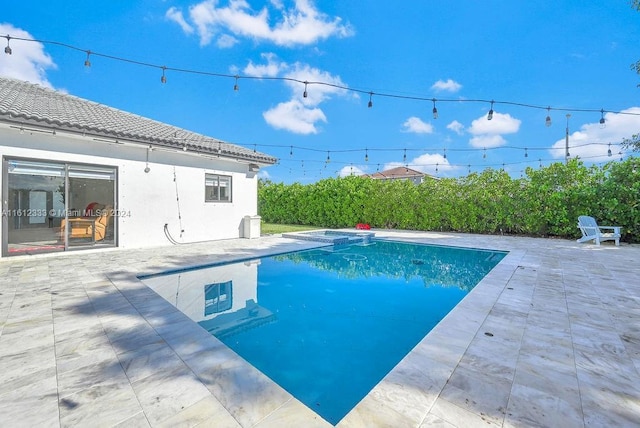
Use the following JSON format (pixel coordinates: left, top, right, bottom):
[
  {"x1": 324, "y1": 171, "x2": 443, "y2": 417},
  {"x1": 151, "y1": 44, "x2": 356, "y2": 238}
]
[{"x1": 549, "y1": 107, "x2": 640, "y2": 162}]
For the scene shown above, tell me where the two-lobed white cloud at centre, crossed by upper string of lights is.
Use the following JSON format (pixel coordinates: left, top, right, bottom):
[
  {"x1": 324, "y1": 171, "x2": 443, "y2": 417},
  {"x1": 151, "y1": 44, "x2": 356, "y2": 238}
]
[{"x1": 244, "y1": 54, "x2": 349, "y2": 134}]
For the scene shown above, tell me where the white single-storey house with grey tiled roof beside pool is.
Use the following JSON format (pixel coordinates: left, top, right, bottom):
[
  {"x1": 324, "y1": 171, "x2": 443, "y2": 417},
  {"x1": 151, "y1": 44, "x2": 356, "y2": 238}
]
[{"x1": 0, "y1": 78, "x2": 276, "y2": 256}]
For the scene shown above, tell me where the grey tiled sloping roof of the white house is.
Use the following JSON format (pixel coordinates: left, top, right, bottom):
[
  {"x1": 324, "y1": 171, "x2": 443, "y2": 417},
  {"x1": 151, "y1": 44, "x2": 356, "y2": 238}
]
[{"x1": 0, "y1": 77, "x2": 277, "y2": 165}]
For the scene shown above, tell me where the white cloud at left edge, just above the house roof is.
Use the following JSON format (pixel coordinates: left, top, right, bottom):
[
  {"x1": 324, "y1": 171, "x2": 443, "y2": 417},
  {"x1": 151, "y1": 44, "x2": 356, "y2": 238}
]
[{"x1": 0, "y1": 23, "x2": 56, "y2": 88}]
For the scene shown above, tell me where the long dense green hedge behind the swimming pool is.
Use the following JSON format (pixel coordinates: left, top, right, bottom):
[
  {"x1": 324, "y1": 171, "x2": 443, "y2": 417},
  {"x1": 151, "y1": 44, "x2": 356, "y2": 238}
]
[{"x1": 258, "y1": 157, "x2": 640, "y2": 242}]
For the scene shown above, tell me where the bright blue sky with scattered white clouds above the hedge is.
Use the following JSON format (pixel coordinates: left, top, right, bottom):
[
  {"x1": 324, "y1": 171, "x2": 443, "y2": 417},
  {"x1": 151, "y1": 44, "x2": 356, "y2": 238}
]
[{"x1": 0, "y1": 0, "x2": 640, "y2": 184}]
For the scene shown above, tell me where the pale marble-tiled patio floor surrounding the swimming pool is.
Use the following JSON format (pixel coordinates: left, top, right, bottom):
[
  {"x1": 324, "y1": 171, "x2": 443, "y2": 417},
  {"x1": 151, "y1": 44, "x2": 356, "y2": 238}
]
[{"x1": 0, "y1": 231, "x2": 640, "y2": 428}]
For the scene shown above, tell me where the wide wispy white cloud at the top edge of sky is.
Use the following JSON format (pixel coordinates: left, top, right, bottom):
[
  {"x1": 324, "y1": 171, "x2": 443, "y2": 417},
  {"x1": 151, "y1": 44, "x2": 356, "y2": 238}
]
[{"x1": 167, "y1": 0, "x2": 353, "y2": 46}]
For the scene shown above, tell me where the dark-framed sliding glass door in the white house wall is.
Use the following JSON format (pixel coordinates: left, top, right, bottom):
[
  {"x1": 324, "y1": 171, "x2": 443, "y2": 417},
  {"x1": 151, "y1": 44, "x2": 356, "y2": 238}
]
[{"x1": 2, "y1": 159, "x2": 116, "y2": 255}]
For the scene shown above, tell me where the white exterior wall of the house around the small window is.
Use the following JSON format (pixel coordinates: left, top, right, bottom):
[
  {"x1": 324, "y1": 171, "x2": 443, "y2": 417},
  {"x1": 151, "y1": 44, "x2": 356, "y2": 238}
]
[{"x1": 0, "y1": 125, "x2": 257, "y2": 248}]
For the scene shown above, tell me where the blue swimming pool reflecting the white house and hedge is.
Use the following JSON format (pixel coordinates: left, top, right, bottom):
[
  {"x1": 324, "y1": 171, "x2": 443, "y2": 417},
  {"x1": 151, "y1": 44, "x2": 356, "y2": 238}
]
[{"x1": 141, "y1": 240, "x2": 506, "y2": 424}]
